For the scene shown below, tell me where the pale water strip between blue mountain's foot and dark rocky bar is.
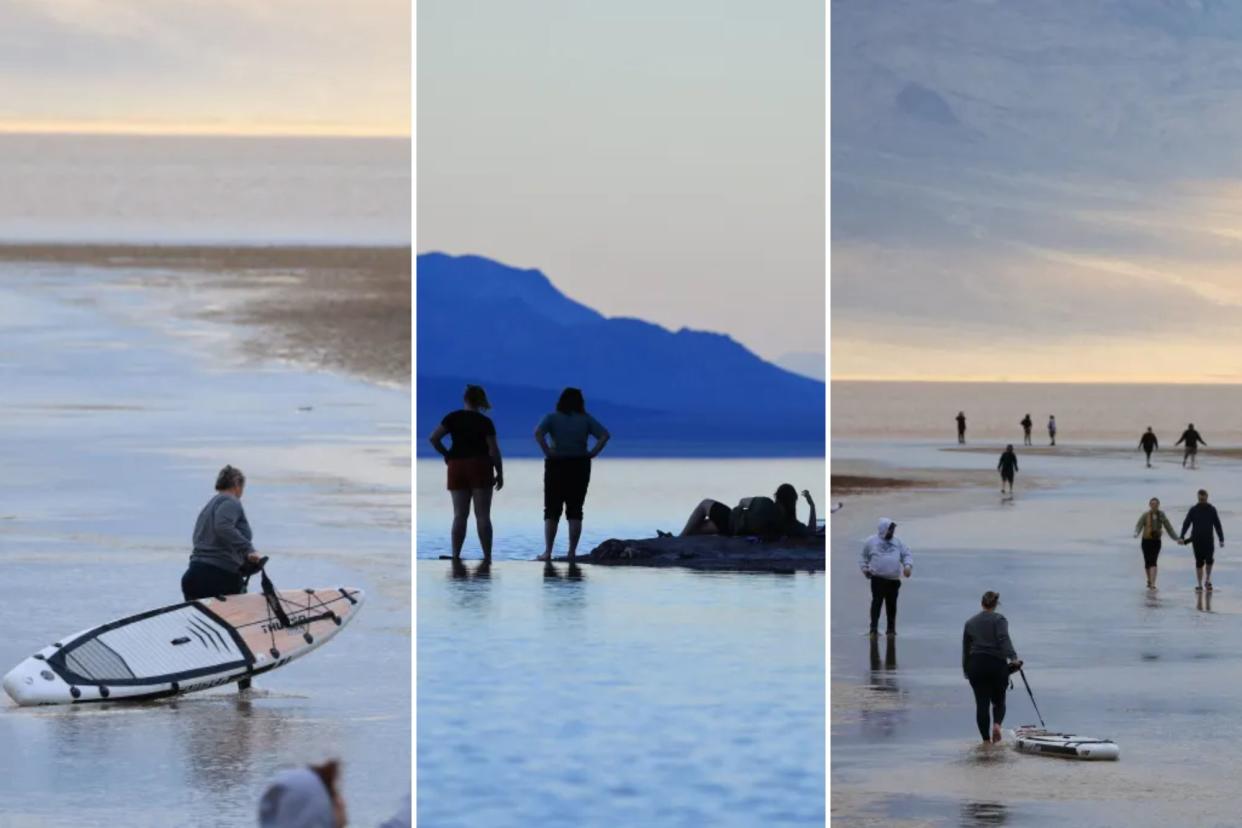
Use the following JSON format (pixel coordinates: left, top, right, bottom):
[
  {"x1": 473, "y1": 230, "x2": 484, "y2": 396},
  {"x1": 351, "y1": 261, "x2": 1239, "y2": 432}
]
[{"x1": 416, "y1": 456, "x2": 826, "y2": 560}]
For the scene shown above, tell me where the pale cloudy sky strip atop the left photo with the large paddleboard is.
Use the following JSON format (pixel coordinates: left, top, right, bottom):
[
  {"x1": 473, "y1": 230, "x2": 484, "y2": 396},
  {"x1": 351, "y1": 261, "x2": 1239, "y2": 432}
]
[{"x1": 0, "y1": 0, "x2": 410, "y2": 135}]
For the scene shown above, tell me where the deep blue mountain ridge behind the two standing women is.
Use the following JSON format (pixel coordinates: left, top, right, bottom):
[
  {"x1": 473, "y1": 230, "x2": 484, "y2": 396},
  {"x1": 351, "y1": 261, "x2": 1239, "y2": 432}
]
[{"x1": 416, "y1": 253, "x2": 825, "y2": 457}]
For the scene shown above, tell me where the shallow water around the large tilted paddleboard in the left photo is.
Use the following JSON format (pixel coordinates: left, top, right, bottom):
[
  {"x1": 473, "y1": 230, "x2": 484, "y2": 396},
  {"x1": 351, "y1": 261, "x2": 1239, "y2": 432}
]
[{"x1": 0, "y1": 264, "x2": 410, "y2": 826}]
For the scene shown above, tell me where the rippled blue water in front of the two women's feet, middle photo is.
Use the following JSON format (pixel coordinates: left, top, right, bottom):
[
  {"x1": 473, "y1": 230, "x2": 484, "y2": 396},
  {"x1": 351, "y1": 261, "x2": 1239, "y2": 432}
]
[{"x1": 417, "y1": 561, "x2": 825, "y2": 828}]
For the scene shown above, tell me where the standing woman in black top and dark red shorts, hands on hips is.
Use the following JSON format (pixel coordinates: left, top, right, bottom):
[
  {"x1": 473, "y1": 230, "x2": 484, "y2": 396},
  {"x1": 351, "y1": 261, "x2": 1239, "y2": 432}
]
[{"x1": 431, "y1": 385, "x2": 504, "y2": 561}]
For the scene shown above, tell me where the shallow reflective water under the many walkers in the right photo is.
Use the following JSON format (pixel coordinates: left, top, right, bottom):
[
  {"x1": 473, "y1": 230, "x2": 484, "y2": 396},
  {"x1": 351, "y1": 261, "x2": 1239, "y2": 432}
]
[{"x1": 830, "y1": 441, "x2": 1242, "y2": 826}]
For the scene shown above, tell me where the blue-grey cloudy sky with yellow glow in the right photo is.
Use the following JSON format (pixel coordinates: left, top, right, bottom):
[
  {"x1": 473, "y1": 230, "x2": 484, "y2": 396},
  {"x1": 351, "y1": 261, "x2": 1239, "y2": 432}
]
[{"x1": 832, "y1": 0, "x2": 1242, "y2": 382}]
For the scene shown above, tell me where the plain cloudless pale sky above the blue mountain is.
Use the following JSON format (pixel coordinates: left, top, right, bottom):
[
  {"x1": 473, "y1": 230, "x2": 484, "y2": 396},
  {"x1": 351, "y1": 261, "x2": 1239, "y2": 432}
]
[{"x1": 417, "y1": 0, "x2": 825, "y2": 358}]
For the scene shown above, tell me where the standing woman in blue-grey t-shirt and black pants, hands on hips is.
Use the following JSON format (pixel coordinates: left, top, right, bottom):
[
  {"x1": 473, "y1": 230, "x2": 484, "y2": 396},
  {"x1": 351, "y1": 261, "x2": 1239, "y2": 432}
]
[{"x1": 535, "y1": 389, "x2": 611, "y2": 562}]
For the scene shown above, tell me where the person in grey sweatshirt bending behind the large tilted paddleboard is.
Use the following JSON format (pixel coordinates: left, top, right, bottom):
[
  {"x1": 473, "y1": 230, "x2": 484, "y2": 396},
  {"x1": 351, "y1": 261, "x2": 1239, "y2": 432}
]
[{"x1": 181, "y1": 466, "x2": 263, "y2": 690}]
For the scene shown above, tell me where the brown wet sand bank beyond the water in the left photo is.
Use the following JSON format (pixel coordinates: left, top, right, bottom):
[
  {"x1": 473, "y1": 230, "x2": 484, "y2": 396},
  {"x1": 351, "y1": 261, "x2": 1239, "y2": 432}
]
[{"x1": 0, "y1": 245, "x2": 411, "y2": 385}]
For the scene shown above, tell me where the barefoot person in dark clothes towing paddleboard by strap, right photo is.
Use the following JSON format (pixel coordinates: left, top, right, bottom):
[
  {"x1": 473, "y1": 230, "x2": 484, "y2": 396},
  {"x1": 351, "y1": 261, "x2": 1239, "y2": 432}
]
[{"x1": 961, "y1": 591, "x2": 1022, "y2": 744}]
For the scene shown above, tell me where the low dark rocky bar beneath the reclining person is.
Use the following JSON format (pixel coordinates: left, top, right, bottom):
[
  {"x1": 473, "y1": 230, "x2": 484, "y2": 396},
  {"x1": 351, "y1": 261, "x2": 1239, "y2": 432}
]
[{"x1": 556, "y1": 535, "x2": 825, "y2": 572}]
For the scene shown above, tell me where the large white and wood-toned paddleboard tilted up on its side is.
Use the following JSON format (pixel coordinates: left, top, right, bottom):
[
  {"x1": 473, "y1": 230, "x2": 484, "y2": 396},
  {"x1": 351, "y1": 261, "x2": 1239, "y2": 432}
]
[{"x1": 4, "y1": 587, "x2": 365, "y2": 705}]
